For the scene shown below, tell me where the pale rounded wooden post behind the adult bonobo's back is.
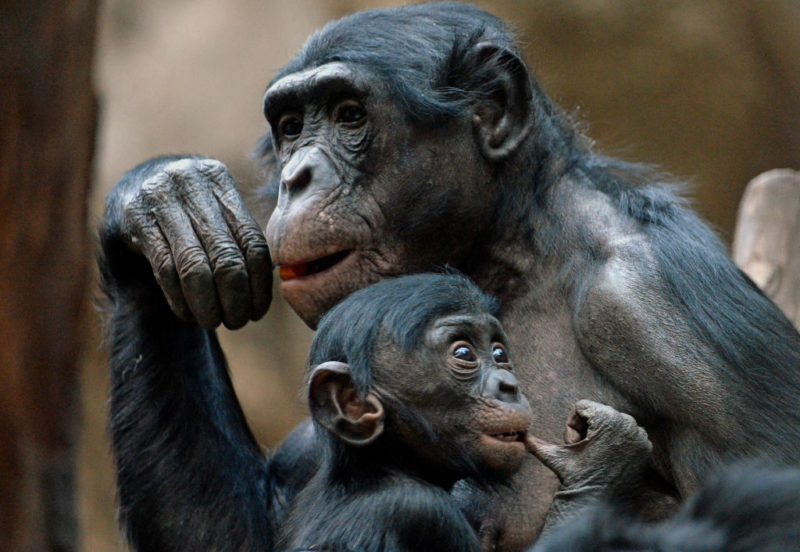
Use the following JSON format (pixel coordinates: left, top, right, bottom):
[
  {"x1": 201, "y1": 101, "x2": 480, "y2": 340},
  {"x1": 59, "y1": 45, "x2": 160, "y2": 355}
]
[{"x1": 732, "y1": 169, "x2": 800, "y2": 328}]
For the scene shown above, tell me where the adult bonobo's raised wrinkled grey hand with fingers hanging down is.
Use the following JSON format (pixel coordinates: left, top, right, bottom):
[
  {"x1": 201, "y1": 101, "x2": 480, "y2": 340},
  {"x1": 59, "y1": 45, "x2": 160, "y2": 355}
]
[{"x1": 105, "y1": 157, "x2": 272, "y2": 329}]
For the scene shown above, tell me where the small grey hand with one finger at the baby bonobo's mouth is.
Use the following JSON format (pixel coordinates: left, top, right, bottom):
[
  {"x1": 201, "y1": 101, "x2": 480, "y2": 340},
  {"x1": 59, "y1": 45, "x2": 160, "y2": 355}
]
[{"x1": 525, "y1": 401, "x2": 653, "y2": 533}]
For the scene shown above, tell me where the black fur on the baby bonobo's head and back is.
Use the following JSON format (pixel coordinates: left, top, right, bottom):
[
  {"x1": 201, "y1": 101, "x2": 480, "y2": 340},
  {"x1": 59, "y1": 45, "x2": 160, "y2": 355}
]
[{"x1": 279, "y1": 274, "x2": 498, "y2": 552}]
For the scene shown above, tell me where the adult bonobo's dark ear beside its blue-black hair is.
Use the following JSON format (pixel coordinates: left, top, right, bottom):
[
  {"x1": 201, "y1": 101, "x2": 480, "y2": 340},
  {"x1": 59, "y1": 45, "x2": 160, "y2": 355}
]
[{"x1": 469, "y1": 42, "x2": 533, "y2": 161}]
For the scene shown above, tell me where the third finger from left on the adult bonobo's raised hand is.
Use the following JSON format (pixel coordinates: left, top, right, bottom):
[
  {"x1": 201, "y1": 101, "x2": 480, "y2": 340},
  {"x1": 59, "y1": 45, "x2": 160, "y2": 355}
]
[{"x1": 173, "y1": 165, "x2": 251, "y2": 329}]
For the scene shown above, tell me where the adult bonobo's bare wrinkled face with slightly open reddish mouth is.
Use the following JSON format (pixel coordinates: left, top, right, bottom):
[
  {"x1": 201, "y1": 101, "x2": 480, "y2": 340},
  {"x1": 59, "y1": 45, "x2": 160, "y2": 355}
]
[{"x1": 264, "y1": 62, "x2": 489, "y2": 327}]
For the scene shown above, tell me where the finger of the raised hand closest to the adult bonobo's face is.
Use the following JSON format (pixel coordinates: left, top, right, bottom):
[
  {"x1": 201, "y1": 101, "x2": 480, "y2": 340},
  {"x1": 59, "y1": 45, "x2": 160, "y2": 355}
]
[{"x1": 210, "y1": 163, "x2": 272, "y2": 320}]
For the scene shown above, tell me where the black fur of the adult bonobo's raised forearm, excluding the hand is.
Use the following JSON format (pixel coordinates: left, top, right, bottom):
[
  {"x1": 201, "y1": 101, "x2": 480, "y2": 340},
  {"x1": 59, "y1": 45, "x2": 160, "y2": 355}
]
[{"x1": 99, "y1": 158, "x2": 317, "y2": 552}]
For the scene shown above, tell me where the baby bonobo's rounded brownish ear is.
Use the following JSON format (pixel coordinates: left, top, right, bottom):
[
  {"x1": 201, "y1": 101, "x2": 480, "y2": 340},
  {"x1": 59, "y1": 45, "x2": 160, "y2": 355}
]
[{"x1": 308, "y1": 361, "x2": 384, "y2": 446}]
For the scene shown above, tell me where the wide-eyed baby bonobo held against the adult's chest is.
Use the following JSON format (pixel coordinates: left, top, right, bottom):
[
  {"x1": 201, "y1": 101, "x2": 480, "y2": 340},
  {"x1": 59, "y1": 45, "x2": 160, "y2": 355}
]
[{"x1": 278, "y1": 274, "x2": 531, "y2": 552}]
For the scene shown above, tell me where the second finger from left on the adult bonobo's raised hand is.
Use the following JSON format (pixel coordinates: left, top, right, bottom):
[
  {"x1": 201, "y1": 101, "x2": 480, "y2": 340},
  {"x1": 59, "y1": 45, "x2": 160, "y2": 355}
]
[{"x1": 142, "y1": 176, "x2": 222, "y2": 328}]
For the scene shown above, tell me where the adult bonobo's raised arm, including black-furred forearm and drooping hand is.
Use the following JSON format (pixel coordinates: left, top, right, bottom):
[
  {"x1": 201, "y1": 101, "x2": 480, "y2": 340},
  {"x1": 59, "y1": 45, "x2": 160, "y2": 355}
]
[{"x1": 100, "y1": 158, "x2": 271, "y2": 551}]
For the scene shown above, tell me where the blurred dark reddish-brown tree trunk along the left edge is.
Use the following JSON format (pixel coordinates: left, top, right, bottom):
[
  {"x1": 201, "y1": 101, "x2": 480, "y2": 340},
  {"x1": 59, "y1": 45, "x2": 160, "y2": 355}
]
[{"x1": 0, "y1": 0, "x2": 97, "y2": 552}]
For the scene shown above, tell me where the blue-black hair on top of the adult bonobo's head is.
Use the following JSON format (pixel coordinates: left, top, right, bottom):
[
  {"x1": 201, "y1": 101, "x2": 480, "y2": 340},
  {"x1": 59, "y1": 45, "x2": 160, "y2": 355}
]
[{"x1": 270, "y1": 2, "x2": 520, "y2": 121}]
